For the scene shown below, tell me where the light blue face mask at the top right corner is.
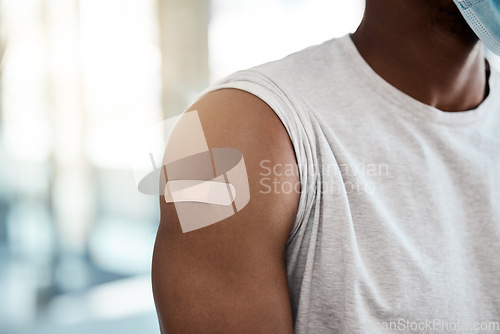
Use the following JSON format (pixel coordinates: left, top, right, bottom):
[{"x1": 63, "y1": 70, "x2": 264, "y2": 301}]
[{"x1": 453, "y1": 0, "x2": 500, "y2": 56}]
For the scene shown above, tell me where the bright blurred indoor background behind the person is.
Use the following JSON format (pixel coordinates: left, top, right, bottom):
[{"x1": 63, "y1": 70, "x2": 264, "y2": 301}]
[{"x1": 0, "y1": 0, "x2": 364, "y2": 334}]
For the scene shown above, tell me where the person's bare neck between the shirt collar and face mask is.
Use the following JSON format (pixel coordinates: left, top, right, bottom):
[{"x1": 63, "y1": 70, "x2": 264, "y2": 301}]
[{"x1": 352, "y1": 0, "x2": 487, "y2": 111}]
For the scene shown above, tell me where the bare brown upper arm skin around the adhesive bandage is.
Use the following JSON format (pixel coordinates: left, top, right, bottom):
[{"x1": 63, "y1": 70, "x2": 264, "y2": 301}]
[{"x1": 152, "y1": 89, "x2": 299, "y2": 334}]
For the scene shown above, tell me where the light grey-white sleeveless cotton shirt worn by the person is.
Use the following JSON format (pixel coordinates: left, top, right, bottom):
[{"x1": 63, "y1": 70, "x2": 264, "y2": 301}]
[{"x1": 201, "y1": 35, "x2": 500, "y2": 334}]
